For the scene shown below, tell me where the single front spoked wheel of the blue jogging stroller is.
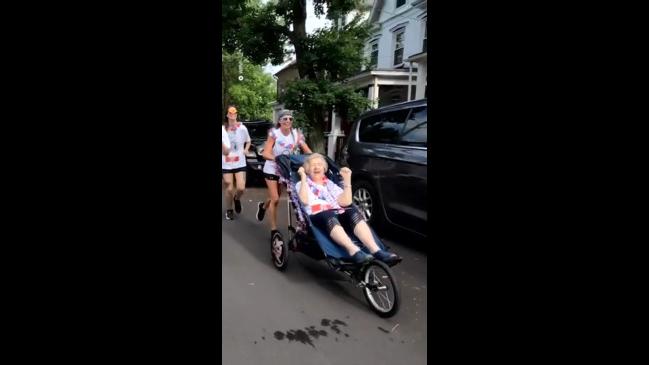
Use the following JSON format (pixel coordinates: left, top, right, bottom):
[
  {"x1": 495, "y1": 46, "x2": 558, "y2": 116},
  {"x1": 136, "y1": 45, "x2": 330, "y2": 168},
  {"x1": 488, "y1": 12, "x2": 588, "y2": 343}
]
[{"x1": 362, "y1": 261, "x2": 401, "y2": 318}]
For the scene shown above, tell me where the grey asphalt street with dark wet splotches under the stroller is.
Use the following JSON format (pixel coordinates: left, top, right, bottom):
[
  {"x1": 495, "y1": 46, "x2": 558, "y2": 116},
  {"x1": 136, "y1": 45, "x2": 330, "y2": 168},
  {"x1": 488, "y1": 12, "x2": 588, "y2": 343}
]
[{"x1": 221, "y1": 186, "x2": 428, "y2": 365}]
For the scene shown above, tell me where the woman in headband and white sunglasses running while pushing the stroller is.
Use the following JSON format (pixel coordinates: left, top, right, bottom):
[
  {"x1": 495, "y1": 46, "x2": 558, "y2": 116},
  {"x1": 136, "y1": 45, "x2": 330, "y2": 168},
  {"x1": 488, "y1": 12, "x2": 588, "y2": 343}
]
[{"x1": 257, "y1": 110, "x2": 312, "y2": 241}]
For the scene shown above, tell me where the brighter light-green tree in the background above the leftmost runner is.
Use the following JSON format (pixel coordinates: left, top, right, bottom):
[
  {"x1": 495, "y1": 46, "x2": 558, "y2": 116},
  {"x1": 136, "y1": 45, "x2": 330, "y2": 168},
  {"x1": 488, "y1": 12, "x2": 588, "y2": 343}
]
[{"x1": 221, "y1": 53, "x2": 276, "y2": 120}]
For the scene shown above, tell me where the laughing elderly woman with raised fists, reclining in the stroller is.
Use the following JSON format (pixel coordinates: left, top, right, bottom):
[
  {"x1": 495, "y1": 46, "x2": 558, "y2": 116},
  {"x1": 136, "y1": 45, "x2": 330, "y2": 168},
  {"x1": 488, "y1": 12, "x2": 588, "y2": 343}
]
[{"x1": 295, "y1": 153, "x2": 401, "y2": 265}]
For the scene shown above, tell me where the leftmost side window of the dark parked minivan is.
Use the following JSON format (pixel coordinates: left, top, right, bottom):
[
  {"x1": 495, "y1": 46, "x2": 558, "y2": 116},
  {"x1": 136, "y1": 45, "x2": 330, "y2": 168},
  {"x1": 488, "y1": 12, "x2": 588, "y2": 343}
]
[{"x1": 358, "y1": 109, "x2": 408, "y2": 143}]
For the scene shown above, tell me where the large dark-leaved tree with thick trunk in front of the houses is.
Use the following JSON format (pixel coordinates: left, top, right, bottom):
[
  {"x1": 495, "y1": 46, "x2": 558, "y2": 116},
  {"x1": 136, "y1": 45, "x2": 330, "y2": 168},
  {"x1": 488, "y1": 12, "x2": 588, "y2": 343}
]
[{"x1": 227, "y1": 0, "x2": 371, "y2": 151}]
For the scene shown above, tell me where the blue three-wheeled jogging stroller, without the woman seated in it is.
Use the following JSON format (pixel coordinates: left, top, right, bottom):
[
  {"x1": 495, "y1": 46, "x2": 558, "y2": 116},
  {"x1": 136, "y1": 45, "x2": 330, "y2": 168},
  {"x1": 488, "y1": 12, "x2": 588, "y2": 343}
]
[{"x1": 271, "y1": 155, "x2": 400, "y2": 318}]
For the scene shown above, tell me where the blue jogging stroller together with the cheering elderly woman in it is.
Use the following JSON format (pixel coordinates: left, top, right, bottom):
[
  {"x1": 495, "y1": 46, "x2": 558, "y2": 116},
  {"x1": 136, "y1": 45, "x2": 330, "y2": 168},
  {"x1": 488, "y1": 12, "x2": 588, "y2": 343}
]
[{"x1": 270, "y1": 153, "x2": 402, "y2": 318}]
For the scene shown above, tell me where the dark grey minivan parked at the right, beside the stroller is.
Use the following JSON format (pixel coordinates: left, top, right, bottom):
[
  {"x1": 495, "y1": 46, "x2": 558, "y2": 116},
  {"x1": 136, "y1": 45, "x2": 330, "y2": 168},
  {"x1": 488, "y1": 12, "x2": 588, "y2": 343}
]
[{"x1": 341, "y1": 99, "x2": 428, "y2": 237}]
